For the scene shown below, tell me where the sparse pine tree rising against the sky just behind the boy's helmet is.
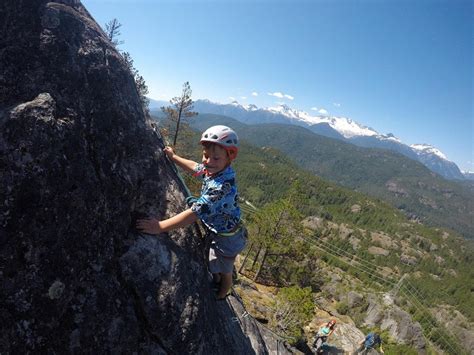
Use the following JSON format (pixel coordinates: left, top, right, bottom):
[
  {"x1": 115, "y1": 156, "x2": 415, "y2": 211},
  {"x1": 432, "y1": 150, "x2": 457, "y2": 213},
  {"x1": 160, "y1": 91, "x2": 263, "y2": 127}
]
[{"x1": 161, "y1": 81, "x2": 198, "y2": 146}]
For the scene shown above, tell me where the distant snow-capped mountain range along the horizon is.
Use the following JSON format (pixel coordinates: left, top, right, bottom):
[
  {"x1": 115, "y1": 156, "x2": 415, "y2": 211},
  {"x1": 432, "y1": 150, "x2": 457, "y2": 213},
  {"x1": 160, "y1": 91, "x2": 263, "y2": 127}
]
[{"x1": 188, "y1": 100, "x2": 465, "y2": 180}]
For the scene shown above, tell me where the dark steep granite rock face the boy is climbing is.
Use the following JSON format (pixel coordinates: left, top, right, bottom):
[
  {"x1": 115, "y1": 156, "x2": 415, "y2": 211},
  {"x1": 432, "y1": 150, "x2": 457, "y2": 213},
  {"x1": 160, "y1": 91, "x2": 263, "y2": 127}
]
[{"x1": 0, "y1": 0, "x2": 276, "y2": 354}]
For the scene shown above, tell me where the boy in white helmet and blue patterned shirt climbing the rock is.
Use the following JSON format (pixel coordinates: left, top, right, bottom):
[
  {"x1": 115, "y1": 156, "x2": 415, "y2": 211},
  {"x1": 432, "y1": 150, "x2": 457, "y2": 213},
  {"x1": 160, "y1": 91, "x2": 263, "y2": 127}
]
[{"x1": 137, "y1": 126, "x2": 247, "y2": 300}]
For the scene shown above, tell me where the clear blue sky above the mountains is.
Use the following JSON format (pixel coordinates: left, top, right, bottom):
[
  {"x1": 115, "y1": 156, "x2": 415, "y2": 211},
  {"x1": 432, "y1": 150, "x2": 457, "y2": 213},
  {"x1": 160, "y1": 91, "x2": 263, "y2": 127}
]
[{"x1": 82, "y1": 0, "x2": 474, "y2": 171}]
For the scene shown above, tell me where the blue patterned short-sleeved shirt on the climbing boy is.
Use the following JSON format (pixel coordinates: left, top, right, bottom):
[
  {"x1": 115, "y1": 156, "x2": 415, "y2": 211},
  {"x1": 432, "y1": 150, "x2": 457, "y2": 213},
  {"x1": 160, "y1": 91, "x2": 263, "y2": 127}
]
[{"x1": 191, "y1": 164, "x2": 240, "y2": 233}]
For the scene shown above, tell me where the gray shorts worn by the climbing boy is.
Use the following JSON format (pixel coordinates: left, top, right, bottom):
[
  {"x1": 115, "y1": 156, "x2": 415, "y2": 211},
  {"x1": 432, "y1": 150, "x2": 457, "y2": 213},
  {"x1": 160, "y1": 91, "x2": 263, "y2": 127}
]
[{"x1": 209, "y1": 227, "x2": 247, "y2": 274}]
